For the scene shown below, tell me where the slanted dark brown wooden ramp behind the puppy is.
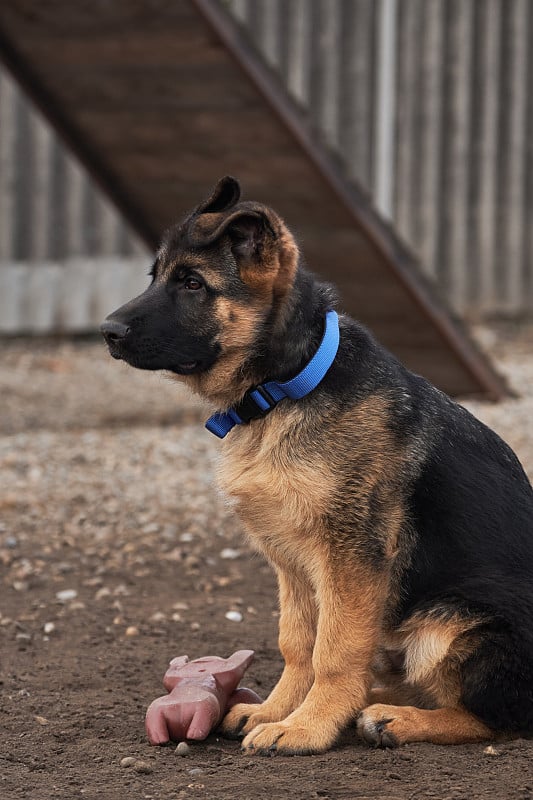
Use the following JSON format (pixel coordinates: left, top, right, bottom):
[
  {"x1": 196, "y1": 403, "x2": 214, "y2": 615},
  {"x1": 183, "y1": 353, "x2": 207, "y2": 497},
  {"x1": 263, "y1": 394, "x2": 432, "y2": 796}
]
[{"x1": 0, "y1": 0, "x2": 507, "y2": 399}]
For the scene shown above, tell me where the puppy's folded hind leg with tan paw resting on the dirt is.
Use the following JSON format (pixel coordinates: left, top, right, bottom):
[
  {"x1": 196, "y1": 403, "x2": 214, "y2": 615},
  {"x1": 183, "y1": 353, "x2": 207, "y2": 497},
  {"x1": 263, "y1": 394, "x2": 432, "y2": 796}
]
[{"x1": 357, "y1": 608, "x2": 533, "y2": 747}]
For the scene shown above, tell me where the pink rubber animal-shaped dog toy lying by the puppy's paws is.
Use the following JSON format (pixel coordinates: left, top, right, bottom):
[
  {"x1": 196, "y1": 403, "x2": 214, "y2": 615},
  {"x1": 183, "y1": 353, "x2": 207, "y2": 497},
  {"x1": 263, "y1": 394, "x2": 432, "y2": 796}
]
[{"x1": 145, "y1": 650, "x2": 262, "y2": 744}]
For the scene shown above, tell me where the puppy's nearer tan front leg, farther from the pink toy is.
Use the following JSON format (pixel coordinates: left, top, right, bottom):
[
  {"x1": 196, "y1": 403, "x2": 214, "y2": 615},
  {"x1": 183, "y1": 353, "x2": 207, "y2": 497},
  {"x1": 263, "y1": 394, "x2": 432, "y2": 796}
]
[{"x1": 242, "y1": 559, "x2": 386, "y2": 755}]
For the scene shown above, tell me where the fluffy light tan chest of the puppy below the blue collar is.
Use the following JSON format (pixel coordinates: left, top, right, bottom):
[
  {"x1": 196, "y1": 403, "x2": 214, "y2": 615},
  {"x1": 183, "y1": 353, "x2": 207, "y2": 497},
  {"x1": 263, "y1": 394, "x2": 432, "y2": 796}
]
[{"x1": 218, "y1": 422, "x2": 333, "y2": 564}]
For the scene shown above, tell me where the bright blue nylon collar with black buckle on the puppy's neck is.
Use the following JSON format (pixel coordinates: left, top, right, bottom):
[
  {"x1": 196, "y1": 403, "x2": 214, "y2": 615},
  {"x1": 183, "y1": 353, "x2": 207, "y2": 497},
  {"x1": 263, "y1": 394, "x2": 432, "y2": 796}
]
[{"x1": 205, "y1": 311, "x2": 340, "y2": 439}]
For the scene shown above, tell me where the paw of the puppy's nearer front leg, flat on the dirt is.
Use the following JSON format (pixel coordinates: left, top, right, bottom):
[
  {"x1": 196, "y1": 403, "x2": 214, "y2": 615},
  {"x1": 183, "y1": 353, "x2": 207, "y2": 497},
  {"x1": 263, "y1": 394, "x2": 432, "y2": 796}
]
[{"x1": 241, "y1": 720, "x2": 336, "y2": 756}]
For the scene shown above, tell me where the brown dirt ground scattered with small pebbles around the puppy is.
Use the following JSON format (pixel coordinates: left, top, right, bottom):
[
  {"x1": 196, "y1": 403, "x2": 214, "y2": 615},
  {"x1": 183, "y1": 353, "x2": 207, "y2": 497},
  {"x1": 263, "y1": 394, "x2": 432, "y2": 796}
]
[{"x1": 0, "y1": 327, "x2": 533, "y2": 800}]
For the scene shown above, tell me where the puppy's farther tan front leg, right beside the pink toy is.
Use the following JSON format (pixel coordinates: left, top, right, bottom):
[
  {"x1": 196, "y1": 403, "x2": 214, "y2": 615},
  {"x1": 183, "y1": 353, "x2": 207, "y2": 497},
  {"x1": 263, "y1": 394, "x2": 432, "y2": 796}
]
[{"x1": 221, "y1": 569, "x2": 318, "y2": 737}]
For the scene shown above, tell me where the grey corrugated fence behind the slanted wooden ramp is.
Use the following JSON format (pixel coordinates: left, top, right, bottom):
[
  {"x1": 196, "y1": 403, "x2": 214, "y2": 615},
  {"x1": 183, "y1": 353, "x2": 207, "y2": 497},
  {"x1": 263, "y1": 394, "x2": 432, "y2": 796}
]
[{"x1": 0, "y1": 0, "x2": 533, "y2": 334}]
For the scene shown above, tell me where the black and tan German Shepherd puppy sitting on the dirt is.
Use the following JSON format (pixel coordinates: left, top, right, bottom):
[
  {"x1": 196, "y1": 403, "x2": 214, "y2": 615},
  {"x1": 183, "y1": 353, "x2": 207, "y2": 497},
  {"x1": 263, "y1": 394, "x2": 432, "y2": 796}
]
[{"x1": 102, "y1": 177, "x2": 533, "y2": 754}]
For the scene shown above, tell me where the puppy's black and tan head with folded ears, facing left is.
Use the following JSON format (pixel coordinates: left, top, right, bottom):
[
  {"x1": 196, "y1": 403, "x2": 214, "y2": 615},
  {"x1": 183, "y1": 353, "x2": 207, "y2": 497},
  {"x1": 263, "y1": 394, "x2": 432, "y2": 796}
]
[{"x1": 101, "y1": 177, "x2": 298, "y2": 396}]
